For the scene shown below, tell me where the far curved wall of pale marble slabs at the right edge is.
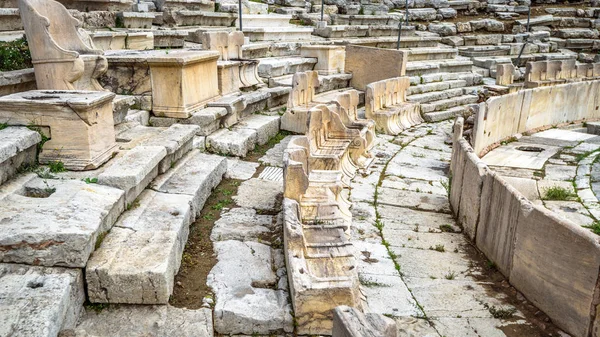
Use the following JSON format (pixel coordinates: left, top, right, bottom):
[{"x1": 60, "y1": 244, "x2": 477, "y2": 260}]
[{"x1": 472, "y1": 81, "x2": 600, "y2": 157}]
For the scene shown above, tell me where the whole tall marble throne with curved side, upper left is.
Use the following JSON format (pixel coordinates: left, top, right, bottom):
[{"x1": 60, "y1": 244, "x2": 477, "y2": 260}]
[{"x1": 19, "y1": 0, "x2": 108, "y2": 91}]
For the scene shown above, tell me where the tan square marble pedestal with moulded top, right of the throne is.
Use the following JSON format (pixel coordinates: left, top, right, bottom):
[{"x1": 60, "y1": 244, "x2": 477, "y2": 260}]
[{"x1": 147, "y1": 51, "x2": 219, "y2": 118}]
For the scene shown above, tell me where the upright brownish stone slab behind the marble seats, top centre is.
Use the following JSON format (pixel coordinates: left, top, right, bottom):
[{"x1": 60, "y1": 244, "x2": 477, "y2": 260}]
[{"x1": 344, "y1": 45, "x2": 408, "y2": 90}]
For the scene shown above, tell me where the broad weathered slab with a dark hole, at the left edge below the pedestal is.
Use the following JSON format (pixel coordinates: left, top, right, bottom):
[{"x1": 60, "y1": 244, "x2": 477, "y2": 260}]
[{"x1": 0, "y1": 178, "x2": 125, "y2": 268}]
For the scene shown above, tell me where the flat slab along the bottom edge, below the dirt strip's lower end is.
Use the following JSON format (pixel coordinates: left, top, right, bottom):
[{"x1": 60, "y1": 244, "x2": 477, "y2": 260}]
[{"x1": 74, "y1": 305, "x2": 213, "y2": 337}]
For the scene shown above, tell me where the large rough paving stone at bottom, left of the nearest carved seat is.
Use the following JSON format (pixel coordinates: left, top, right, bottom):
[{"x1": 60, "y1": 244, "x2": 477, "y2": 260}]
[{"x1": 207, "y1": 240, "x2": 293, "y2": 335}]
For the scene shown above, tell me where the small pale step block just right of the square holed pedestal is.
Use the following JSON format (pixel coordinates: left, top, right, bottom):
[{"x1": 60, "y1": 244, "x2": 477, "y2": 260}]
[{"x1": 142, "y1": 124, "x2": 200, "y2": 174}]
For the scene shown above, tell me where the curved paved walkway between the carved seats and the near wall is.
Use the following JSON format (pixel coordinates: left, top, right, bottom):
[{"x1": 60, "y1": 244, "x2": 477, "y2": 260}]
[{"x1": 351, "y1": 122, "x2": 553, "y2": 337}]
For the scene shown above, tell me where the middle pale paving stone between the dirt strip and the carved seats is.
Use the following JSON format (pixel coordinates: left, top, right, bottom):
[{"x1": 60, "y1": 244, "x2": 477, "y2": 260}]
[{"x1": 210, "y1": 208, "x2": 273, "y2": 241}]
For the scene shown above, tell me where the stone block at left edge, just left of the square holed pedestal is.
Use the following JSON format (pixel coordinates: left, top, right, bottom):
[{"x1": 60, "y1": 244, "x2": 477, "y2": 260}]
[{"x1": 0, "y1": 127, "x2": 42, "y2": 184}]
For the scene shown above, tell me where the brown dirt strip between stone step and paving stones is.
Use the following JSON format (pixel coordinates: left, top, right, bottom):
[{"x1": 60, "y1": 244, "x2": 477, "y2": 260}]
[{"x1": 169, "y1": 179, "x2": 241, "y2": 309}]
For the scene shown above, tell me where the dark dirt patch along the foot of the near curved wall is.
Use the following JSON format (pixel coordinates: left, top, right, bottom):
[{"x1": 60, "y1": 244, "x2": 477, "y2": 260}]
[{"x1": 464, "y1": 238, "x2": 560, "y2": 337}]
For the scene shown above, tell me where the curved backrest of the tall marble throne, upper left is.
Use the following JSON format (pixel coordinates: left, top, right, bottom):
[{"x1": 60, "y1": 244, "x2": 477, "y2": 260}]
[{"x1": 19, "y1": 0, "x2": 103, "y2": 62}]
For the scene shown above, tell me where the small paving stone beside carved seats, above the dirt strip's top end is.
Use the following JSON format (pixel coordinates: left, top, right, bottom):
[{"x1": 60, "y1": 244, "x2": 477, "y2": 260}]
[{"x1": 233, "y1": 178, "x2": 283, "y2": 211}]
